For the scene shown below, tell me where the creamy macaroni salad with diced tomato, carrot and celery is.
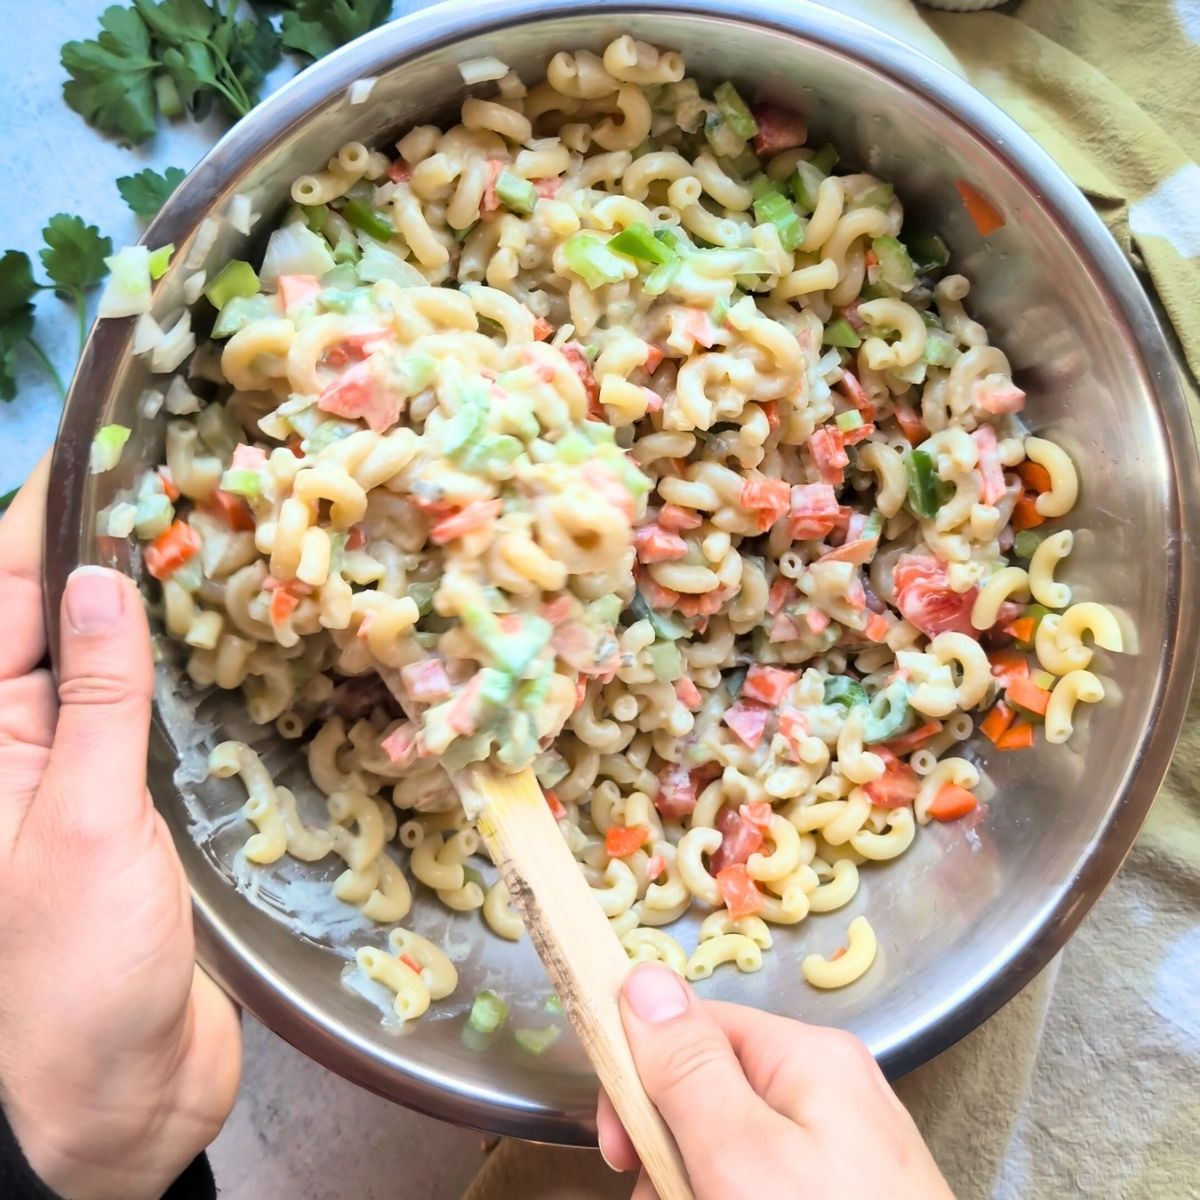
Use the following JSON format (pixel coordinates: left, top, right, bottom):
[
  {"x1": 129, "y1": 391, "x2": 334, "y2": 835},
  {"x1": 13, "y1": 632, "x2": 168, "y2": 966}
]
[{"x1": 106, "y1": 36, "x2": 1122, "y2": 1019}]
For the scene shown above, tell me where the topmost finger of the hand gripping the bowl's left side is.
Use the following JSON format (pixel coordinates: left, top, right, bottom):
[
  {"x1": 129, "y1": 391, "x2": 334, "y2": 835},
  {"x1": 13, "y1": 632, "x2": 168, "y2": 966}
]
[{"x1": 0, "y1": 452, "x2": 50, "y2": 679}]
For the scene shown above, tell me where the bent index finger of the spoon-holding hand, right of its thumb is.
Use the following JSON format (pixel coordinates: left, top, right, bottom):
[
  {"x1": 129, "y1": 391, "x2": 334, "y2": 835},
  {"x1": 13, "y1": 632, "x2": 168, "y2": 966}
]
[{"x1": 704, "y1": 1001, "x2": 900, "y2": 1127}]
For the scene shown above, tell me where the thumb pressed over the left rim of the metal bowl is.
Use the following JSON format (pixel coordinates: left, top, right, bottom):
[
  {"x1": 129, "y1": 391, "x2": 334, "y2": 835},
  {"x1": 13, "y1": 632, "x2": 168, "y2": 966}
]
[{"x1": 38, "y1": 566, "x2": 154, "y2": 834}]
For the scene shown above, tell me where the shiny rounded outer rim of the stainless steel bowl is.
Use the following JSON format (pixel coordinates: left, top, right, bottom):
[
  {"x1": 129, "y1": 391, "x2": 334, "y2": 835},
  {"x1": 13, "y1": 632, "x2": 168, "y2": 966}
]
[{"x1": 43, "y1": 0, "x2": 1200, "y2": 1145}]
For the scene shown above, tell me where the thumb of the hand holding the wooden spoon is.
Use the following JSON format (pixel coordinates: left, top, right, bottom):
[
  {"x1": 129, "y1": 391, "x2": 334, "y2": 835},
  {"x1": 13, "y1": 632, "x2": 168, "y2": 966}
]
[{"x1": 620, "y1": 962, "x2": 763, "y2": 1178}]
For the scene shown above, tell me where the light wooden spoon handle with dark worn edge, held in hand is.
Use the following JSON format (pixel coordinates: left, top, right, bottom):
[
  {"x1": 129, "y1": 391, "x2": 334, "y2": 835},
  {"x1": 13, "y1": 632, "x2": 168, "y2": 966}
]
[{"x1": 455, "y1": 768, "x2": 692, "y2": 1200}]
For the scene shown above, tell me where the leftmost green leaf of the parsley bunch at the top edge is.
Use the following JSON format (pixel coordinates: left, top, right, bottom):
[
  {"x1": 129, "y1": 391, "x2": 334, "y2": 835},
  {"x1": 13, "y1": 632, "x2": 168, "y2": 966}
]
[{"x1": 62, "y1": 5, "x2": 157, "y2": 145}]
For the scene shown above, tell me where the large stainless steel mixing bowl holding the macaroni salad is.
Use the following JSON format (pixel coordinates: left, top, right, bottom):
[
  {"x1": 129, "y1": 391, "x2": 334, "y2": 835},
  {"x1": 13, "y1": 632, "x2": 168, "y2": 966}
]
[{"x1": 47, "y1": 0, "x2": 1200, "y2": 1144}]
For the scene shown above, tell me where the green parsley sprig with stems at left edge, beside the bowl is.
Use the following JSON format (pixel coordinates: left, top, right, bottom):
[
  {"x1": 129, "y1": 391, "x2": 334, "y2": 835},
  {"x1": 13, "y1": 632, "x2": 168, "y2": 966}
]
[{"x1": 0, "y1": 212, "x2": 113, "y2": 401}]
